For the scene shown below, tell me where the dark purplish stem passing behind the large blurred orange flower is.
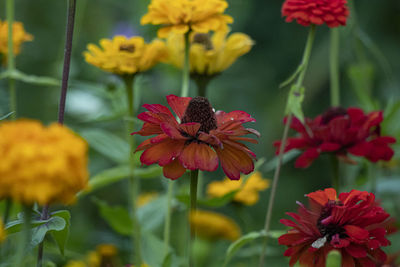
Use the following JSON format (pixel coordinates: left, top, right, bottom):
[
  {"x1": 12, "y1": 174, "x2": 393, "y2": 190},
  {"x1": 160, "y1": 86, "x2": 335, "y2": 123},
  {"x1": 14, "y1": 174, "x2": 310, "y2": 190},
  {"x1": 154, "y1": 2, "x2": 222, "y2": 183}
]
[{"x1": 37, "y1": 0, "x2": 76, "y2": 267}]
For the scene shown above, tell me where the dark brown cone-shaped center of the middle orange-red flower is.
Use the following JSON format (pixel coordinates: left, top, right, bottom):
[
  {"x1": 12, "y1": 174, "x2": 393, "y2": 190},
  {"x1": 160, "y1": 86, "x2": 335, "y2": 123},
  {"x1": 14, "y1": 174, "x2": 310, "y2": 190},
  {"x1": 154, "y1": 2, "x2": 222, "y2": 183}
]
[{"x1": 182, "y1": 96, "x2": 217, "y2": 133}]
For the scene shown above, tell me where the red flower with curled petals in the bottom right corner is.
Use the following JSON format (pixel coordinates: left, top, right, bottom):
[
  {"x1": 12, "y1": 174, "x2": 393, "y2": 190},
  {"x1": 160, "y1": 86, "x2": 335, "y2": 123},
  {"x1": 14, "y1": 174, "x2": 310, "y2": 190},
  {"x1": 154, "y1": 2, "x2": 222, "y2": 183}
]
[{"x1": 278, "y1": 188, "x2": 390, "y2": 267}]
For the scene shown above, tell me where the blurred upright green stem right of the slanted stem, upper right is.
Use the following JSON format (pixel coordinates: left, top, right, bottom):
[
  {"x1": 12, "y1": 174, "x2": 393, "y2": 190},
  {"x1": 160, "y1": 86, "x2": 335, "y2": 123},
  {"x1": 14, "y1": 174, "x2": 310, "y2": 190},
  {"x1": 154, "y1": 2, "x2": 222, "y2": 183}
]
[{"x1": 329, "y1": 28, "x2": 340, "y2": 107}]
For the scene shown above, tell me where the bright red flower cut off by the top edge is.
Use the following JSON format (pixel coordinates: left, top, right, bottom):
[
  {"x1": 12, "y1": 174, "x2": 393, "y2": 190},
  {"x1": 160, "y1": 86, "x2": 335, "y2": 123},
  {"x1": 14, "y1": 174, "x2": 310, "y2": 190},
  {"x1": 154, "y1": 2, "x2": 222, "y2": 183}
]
[{"x1": 282, "y1": 0, "x2": 349, "y2": 28}]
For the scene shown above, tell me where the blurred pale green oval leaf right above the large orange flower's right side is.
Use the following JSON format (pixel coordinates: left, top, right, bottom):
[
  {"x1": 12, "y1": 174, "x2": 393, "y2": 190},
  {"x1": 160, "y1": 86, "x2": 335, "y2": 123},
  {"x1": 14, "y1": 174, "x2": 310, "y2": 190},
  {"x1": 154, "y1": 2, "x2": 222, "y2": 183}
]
[{"x1": 80, "y1": 129, "x2": 133, "y2": 163}]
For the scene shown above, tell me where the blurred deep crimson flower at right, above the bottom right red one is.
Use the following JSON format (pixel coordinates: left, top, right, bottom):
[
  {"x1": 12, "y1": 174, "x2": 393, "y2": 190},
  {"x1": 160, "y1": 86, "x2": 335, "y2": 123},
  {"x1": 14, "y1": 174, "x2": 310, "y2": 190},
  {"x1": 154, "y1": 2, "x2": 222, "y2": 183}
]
[{"x1": 274, "y1": 108, "x2": 396, "y2": 168}]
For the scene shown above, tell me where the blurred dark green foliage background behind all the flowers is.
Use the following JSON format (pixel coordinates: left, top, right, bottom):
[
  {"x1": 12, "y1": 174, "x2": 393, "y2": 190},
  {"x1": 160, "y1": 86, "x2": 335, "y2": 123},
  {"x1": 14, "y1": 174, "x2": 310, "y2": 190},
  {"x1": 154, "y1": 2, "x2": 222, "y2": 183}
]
[{"x1": 0, "y1": 0, "x2": 400, "y2": 266}]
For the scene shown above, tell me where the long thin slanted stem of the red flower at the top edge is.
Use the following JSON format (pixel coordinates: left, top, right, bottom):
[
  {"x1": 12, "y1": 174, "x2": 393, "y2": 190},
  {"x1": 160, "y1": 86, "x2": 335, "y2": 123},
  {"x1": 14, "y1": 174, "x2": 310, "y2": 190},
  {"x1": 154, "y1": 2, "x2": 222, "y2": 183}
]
[{"x1": 259, "y1": 25, "x2": 316, "y2": 267}]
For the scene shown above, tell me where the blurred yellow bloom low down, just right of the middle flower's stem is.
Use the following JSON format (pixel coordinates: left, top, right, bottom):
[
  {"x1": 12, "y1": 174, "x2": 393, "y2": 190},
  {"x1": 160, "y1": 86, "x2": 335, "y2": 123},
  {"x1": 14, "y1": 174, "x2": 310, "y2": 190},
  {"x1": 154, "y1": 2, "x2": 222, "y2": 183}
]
[{"x1": 190, "y1": 210, "x2": 241, "y2": 241}]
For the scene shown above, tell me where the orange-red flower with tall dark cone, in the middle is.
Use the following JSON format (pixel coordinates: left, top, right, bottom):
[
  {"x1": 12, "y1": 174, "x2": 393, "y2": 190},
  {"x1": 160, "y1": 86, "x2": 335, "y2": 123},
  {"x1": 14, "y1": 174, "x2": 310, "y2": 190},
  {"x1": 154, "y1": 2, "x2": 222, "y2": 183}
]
[{"x1": 133, "y1": 95, "x2": 259, "y2": 180}]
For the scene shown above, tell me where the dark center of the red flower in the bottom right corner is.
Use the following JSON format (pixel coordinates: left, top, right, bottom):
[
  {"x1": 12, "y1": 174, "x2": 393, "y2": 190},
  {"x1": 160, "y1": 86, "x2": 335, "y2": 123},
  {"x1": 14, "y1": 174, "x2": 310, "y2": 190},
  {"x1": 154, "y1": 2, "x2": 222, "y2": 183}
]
[{"x1": 317, "y1": 200, "x2": 347, "y2": 243}]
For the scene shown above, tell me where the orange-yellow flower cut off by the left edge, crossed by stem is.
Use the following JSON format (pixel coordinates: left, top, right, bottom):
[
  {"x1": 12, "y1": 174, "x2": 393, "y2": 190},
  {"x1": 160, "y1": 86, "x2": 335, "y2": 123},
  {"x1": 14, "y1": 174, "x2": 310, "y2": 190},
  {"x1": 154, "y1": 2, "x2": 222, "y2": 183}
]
[{"x1": 0, "y1": 20, "x2": 33, "y2": 56}]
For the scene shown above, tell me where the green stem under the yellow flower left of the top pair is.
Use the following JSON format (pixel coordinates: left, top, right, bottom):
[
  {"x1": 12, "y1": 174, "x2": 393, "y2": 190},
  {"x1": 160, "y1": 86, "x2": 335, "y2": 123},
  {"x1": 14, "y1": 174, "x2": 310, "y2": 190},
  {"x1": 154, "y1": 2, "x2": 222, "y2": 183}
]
[{"x1": 124, "y1": 75, "x2": 142, "y2": 266}]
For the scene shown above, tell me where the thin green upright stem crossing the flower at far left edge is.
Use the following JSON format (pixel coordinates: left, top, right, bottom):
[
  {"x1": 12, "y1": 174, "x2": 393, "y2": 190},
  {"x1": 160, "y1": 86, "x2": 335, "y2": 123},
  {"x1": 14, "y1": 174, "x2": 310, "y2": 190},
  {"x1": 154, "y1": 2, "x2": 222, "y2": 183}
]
[{"x1": 6, "y1": 0, "x2": 17, "y2": 120}]
